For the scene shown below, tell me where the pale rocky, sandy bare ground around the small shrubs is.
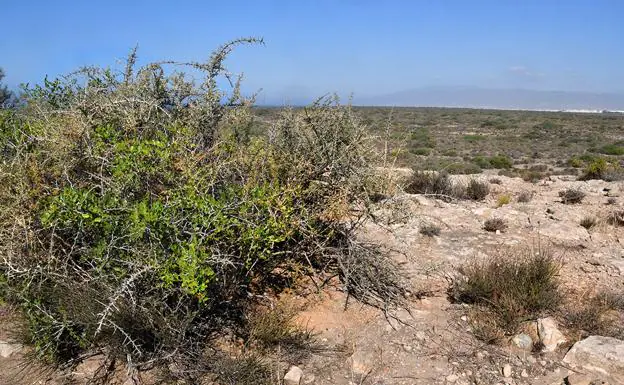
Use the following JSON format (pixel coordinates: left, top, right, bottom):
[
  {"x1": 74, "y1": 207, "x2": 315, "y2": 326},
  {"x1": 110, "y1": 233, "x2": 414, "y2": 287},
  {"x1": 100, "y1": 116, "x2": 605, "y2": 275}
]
[{"x1": 0, "y1": 174, "x2": 624, "y2": 385}]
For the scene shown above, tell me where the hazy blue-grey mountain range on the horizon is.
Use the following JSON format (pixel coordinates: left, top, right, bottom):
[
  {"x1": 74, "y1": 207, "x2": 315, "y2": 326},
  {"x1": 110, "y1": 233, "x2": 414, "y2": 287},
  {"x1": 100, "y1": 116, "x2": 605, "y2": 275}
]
[{"x1": 353, "y1": 87, "x2": 624, "y2": 111}]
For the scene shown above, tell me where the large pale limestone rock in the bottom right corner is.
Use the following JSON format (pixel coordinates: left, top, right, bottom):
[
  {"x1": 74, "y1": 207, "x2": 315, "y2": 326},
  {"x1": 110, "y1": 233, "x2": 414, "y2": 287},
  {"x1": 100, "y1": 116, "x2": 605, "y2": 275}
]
[{"x1": 563, "y1": 336, "x2": 624, "y2": 384}]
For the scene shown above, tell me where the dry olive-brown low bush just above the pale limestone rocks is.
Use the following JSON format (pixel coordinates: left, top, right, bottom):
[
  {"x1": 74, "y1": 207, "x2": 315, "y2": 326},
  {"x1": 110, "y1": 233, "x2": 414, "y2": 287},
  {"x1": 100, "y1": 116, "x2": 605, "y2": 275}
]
[{"x1": 449, "y1": 248, "x2": 561, "y2": 336}]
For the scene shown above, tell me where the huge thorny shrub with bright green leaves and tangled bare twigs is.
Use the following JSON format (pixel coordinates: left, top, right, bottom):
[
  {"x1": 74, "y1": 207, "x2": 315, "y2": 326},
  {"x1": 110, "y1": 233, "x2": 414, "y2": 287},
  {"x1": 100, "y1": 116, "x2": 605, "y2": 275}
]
[{"x1": 0, "y1": 39, "x2": 406, "y2": 378}]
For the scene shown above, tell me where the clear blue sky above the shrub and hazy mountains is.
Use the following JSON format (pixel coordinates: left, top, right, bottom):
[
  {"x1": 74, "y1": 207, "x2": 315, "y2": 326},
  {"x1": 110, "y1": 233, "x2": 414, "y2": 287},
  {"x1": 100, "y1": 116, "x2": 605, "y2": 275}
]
[{"x1": 0, "y1": 0, "x2": 624, "y2": 101}]
